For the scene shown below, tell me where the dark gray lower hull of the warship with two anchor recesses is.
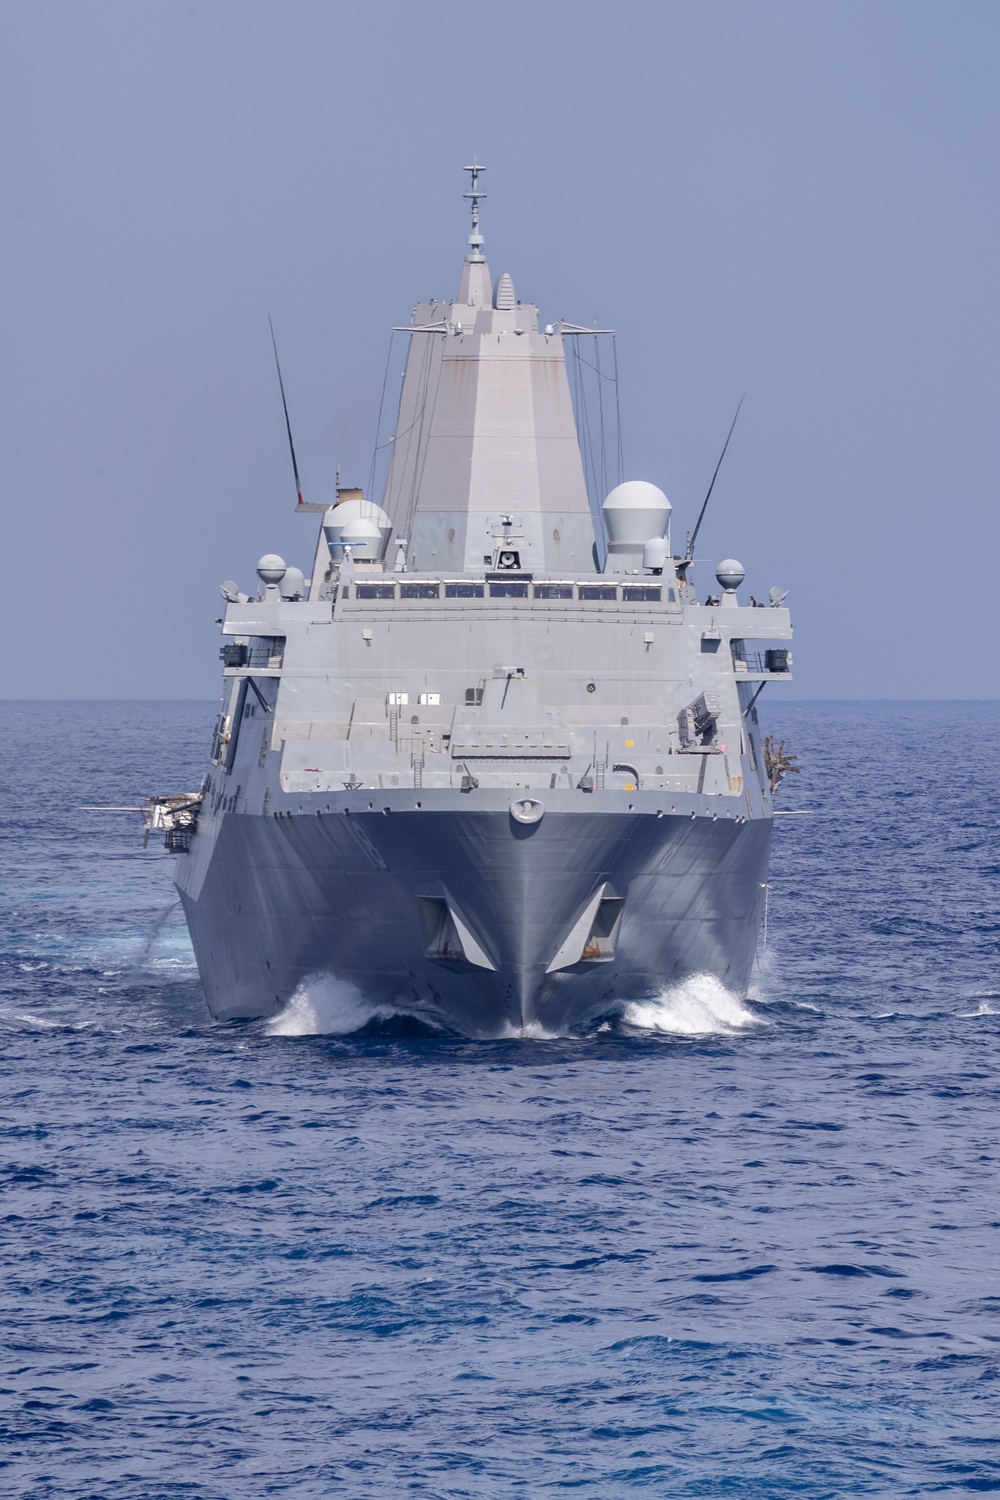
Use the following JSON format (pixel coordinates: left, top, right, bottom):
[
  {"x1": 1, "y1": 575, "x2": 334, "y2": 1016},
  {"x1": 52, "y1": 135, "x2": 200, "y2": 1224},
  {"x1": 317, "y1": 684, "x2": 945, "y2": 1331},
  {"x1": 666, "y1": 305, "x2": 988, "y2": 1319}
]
[{"x1": 178, "y1": 791, "x2": 771, "y2": 1037}]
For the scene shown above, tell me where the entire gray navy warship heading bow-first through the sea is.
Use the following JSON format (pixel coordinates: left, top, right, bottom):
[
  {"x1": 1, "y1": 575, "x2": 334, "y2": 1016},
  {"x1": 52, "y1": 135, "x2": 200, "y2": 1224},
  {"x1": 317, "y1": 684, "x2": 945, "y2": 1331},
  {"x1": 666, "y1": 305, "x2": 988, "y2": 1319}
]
[{"x1": 162, "y1": 165, "x2": 792, "y2": 1037}]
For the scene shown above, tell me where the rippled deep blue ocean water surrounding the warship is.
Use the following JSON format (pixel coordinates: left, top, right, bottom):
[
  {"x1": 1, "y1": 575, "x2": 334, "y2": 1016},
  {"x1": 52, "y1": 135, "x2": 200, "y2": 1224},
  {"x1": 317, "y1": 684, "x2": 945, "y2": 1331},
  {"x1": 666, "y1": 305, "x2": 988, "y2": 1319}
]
[{"x1": 0, "y1": 695, "x2": 1000, "y2": 1500}]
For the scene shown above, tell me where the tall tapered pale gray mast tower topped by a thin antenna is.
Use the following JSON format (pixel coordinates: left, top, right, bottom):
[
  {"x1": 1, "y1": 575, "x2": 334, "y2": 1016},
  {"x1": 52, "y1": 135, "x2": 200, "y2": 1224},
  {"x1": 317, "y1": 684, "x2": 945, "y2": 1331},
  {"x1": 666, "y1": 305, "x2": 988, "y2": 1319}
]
[{"x1": 384, "y1": 161, "x2": 597, "y2": 573}]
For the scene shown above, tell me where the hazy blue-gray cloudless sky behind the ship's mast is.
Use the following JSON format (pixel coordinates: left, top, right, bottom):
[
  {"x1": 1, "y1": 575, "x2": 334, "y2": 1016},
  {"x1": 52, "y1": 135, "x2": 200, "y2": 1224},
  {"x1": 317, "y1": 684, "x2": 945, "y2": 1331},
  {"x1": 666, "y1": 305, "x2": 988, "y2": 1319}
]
[{"x1": 0, "y1": 0, "x2": 1000, "y2": 698}]
